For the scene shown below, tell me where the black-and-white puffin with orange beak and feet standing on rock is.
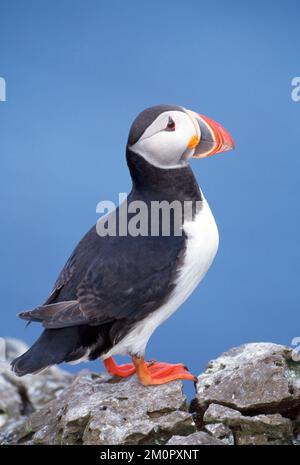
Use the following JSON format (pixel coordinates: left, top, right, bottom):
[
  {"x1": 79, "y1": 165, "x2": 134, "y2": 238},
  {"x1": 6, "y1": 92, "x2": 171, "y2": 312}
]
[{"x1": 11, "y1": 104, "x2": 234, "y2": 386}]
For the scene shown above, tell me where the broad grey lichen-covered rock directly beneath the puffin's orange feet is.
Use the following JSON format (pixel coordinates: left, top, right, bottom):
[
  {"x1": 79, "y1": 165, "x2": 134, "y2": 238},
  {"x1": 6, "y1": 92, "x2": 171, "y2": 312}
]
[{"x1": 20, "y1": 371, "x2": 195, "y2": 444}]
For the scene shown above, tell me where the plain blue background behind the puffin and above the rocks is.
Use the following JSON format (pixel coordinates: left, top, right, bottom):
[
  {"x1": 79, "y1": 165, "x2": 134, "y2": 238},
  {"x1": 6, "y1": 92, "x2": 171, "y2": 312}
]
[{"x1": 0, "y1": 0, "x2": 300, "y2": 396}]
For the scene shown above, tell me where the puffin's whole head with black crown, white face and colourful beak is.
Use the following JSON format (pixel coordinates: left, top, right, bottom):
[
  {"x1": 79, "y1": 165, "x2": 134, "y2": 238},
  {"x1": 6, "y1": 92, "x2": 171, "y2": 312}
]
[{"x1": 127, "y1": 105, "x2": 234, "y2": 168}]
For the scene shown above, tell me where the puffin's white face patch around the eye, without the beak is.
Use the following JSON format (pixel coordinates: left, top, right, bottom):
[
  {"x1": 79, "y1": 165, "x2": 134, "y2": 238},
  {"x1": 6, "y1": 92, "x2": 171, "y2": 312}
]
[{"x1": 130, "y1": 111, "x2": 199, "y2": 169}]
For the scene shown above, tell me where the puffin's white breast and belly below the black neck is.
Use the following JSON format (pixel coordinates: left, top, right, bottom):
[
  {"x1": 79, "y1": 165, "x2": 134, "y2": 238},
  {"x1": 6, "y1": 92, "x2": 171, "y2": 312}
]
[{"x1": 103, "y1": 194, "x2": 219, "y2": 358}]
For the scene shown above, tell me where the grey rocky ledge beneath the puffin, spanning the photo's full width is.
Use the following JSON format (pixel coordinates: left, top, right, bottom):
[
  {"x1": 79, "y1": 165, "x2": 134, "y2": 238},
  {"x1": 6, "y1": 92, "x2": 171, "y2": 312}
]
[{"x1": 0, "y1": 339, "x2": 300, "y2": 445}]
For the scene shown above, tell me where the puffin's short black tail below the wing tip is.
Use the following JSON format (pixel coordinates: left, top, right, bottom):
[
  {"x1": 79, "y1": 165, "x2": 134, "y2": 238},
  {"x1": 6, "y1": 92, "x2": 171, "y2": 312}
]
[{"x1": 11, "y1": 326, "x2": 87, "y2": 376}]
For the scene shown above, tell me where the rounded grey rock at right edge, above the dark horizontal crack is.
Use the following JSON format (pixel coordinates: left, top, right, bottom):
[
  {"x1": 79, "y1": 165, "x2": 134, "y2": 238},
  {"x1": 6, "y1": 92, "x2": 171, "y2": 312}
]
[{"x1": 197, "y1": 343, "x2": 300, "y2": 414}]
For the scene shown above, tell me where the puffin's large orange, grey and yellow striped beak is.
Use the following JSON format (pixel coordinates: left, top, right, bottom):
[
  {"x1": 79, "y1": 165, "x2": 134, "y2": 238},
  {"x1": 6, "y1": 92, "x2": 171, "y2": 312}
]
[{"x1": 186, "y1": 110, "x2": 234, "y2": 158}]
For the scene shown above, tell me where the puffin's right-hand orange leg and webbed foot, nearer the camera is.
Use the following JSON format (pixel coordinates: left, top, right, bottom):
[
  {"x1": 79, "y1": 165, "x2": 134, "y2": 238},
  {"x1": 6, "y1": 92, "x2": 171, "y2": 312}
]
[{"x1": 132, "y1": 357, "x2": 197, "y2": 386}]
